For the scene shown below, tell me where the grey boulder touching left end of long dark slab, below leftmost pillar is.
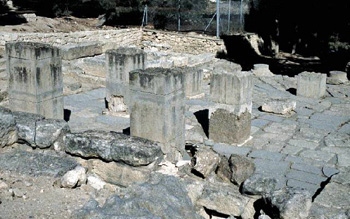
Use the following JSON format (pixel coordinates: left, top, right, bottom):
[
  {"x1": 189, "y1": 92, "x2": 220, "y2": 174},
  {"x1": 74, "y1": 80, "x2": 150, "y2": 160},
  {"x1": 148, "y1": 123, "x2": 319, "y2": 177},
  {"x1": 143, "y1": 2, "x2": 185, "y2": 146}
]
[{"x1": 35, "y1": 119, "x2": 70, "y2": 148}]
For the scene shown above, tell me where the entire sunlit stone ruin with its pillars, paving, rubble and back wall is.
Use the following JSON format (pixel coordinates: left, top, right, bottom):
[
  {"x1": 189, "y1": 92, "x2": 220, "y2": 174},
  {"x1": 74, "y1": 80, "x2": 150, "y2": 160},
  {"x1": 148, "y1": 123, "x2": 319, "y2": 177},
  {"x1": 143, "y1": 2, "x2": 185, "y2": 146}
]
[{"x1": 0, "y1": 18, "x2": 350, "y2": 219}]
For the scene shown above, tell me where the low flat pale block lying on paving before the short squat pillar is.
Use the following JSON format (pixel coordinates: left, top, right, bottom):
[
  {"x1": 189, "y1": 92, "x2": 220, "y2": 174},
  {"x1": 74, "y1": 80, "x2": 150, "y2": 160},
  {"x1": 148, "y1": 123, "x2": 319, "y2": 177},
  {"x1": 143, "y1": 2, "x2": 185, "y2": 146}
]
[{"x1": 261, "y1": 99, "x2": 296, "y2": 115}]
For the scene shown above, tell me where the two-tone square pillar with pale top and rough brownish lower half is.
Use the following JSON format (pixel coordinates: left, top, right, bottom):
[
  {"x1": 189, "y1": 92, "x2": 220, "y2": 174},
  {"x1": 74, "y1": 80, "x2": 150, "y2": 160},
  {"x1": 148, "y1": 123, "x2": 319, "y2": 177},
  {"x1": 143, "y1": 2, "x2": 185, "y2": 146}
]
[{"x1": 209, "y1": 60, "x2": 253, "y2": 145}]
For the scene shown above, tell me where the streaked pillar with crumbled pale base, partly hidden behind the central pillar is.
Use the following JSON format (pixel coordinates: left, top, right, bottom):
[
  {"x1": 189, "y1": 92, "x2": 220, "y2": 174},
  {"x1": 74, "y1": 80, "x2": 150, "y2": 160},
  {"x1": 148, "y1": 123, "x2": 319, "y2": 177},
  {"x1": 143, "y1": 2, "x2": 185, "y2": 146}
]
[{"x1": 106, "y1": 47, "x2": 146, "y2": 112}]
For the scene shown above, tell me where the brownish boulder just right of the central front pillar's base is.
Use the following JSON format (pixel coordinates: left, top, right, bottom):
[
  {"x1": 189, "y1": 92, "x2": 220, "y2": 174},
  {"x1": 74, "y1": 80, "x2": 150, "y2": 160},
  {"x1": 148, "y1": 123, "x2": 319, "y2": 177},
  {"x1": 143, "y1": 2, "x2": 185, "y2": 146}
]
[{"x1": 191, "y1": 147, "x2": 220, "y2": 178}]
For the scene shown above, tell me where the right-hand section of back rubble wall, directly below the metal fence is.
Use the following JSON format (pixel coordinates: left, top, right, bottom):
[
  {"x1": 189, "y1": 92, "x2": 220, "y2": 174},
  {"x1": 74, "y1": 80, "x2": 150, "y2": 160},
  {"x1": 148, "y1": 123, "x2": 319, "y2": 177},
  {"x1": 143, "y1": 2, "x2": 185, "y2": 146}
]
[{"x1": 142, "y1": 29, "x2": 225, "y2": 54}]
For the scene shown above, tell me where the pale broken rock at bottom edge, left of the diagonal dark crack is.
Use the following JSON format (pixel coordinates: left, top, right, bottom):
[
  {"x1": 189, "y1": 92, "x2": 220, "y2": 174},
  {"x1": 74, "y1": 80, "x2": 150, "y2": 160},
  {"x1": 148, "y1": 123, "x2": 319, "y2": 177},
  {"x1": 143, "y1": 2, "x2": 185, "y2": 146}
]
[{"x1": 265, "y1": 189, "x2": 312, "y2": 219}]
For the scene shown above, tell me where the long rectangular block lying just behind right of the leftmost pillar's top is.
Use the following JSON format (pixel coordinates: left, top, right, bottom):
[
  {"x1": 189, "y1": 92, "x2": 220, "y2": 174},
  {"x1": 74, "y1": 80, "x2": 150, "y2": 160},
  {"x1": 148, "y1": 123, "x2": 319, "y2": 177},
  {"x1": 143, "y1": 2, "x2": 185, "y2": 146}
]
[{"x1": 60, "y1": 42, "x2": 103, "y2": 60}]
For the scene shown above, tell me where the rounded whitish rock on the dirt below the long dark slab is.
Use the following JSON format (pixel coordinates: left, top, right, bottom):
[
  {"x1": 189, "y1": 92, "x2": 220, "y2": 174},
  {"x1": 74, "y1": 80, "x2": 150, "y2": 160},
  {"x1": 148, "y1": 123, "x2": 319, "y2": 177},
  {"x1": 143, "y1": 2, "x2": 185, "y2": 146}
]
[{"x1": 61, "y1": 166, "x2": 87, "y2": 188}]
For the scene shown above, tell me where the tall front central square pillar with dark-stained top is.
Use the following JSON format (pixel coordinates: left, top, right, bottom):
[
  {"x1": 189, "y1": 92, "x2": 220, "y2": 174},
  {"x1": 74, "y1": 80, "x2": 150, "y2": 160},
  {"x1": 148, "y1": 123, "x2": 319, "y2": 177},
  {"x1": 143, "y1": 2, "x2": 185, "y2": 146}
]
[{"x1": 130, "y1": 68, "x2": 185, "y2": 162}]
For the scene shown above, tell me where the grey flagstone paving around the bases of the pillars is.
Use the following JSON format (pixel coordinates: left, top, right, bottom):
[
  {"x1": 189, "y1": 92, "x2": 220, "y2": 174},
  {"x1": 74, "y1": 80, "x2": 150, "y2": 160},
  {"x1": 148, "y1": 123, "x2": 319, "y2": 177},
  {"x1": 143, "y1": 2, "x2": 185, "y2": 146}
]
[{"x1": 65, "y1": 75, "x2": 350, "y2": 218}]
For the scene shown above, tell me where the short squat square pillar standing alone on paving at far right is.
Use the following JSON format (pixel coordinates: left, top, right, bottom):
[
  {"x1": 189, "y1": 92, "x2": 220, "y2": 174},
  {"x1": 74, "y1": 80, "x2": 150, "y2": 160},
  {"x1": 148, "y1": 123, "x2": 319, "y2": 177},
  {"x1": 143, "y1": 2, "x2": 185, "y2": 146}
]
[{"x1": 297, "y1": 72, "x2": 327, "y2": 98}]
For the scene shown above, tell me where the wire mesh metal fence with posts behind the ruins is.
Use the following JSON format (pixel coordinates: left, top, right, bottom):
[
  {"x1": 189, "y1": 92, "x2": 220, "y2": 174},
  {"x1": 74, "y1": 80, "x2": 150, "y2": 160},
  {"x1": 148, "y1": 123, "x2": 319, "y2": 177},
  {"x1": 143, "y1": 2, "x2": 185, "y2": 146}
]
[{"x1": 142, "y1": 0, "x2": 249, "y2": 37}]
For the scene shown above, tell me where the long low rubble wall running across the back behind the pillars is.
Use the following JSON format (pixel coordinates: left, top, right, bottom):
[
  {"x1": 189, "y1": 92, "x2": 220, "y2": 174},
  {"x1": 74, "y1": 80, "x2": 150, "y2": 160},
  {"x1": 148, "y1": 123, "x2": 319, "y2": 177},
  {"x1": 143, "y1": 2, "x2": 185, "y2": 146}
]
[{"x1": 0, "y1": 28, "x2": 225, "y2": 54}]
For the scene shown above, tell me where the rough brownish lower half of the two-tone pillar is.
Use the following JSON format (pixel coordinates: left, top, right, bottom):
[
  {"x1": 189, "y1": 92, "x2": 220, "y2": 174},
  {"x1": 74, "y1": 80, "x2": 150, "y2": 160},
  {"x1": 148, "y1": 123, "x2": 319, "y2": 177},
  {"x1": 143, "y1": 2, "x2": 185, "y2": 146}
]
[{"x1": 209, "y1": 109, "x2": 251, "y2": 144}]
